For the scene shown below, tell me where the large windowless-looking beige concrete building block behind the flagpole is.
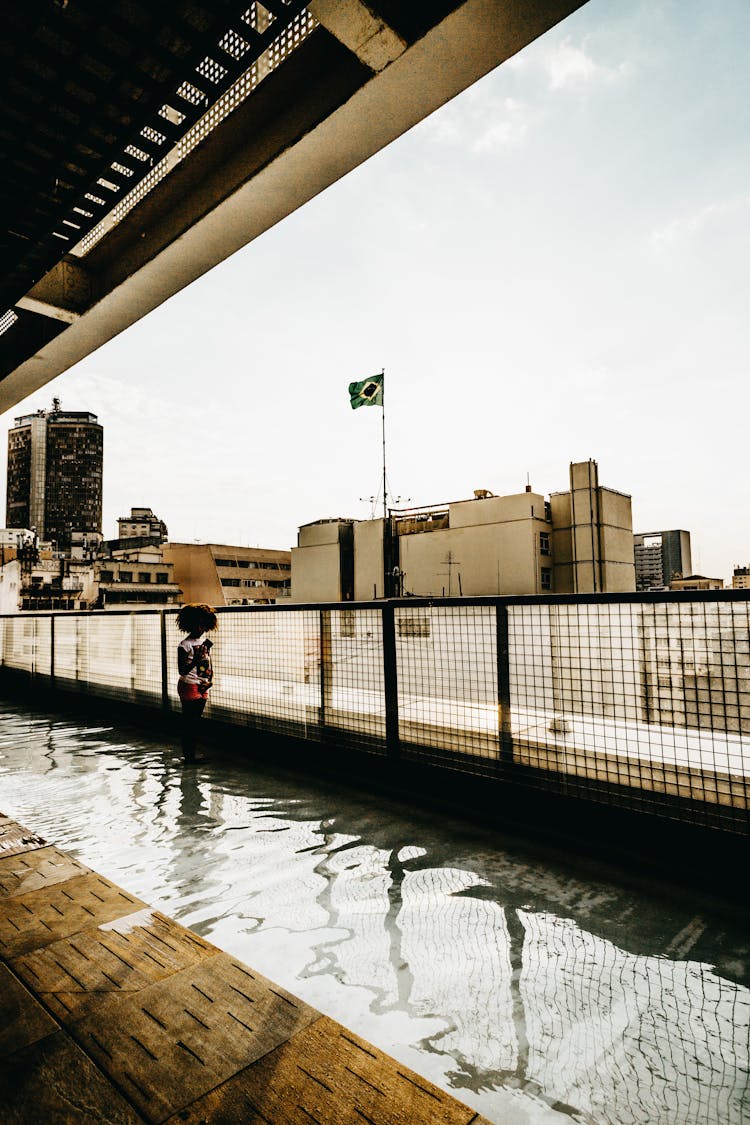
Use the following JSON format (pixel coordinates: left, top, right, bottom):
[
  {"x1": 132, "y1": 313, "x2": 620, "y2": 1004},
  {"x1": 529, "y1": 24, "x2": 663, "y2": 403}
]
[{"x1": 291, "y1": 461, "x2": 634, "y2": 602}]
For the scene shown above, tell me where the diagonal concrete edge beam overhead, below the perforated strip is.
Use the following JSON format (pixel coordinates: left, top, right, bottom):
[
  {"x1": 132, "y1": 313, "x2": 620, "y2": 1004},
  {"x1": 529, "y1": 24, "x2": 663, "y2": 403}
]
[{"x1": 0, "y1": 0, "x2": 586, "y2": 412}]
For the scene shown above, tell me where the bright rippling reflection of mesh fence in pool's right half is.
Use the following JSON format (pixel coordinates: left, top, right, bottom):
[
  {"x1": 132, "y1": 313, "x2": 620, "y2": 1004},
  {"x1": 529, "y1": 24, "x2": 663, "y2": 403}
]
[{"x1": 292, "y1": 844, "x2": 750, "y2": 1125}]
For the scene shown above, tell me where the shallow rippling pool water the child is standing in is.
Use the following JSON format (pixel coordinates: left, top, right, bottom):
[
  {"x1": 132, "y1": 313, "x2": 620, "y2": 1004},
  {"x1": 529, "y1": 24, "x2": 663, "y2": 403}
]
[{"x1": 0, "y1": 703, "x2": 750, "y2": 1125}]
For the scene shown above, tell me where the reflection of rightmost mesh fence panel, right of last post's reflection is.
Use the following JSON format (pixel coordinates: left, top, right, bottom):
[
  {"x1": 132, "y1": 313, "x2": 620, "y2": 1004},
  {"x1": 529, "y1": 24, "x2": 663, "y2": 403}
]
[{"x1": 519, "y1": 911, "x2": 750, "y2": 1125}]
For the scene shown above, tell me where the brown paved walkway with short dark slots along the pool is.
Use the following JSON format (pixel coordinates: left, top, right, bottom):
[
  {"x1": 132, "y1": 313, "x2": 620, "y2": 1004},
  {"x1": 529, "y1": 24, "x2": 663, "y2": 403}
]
[{"x1": 0, "y1": 815, "x2": 489, "y2": 1125}]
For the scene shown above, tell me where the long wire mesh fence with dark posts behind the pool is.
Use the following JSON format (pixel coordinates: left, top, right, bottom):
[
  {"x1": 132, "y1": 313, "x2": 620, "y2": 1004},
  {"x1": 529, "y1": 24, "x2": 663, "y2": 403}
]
[{"x1": 0, "y1": 593, "x2": 750, "y2": 833}]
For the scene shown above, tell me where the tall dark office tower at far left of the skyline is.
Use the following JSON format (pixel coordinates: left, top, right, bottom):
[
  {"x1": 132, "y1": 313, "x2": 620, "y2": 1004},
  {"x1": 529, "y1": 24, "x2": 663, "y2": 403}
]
[{"x1": 6, "y1": 399, "x2": 103, "y2": 549}]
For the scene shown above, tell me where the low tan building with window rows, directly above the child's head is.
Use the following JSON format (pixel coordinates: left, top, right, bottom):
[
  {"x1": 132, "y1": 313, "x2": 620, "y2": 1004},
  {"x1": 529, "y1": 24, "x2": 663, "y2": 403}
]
[{"x1": 162, "y1": 543, "x2": 291, "y2": 605}]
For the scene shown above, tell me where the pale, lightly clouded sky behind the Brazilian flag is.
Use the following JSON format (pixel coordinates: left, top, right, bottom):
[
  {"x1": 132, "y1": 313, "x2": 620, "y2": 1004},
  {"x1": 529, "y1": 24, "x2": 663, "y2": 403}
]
[{"x1": 0, "y1": 0, "x2": 750, "y2": 582}]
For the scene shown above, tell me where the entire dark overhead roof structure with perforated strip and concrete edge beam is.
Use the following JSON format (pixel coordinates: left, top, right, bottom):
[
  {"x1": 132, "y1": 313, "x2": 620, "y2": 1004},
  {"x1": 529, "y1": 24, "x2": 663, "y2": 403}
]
[{"x1": 0, "y1": 0, "x2": 585, "y2": 411}]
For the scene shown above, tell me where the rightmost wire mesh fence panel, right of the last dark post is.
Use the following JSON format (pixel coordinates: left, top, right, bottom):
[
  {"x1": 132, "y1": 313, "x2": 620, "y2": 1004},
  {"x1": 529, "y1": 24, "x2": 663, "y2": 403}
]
[{"x1": 508, "y1": 602, "x2": 750, "y2": 826}]
